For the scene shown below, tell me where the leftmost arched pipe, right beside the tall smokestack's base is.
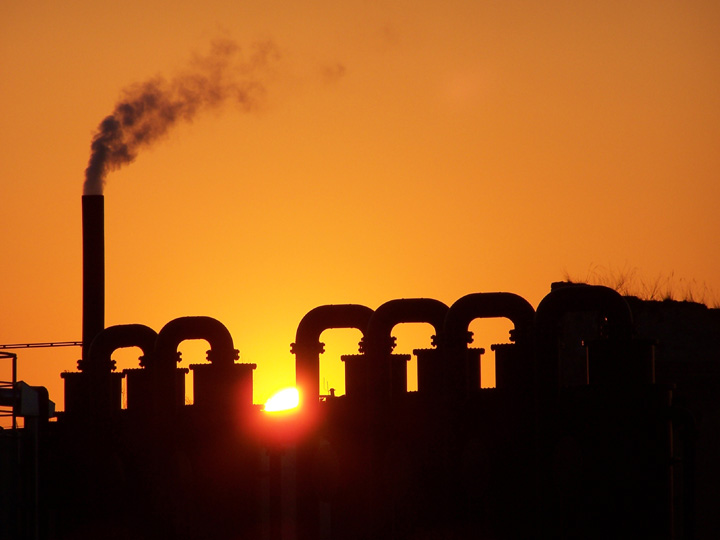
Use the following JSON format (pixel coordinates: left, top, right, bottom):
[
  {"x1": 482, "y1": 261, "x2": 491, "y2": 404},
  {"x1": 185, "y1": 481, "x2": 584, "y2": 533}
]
[{"x1": 80, "y1": 324, "x2": 157, "y2": 372}]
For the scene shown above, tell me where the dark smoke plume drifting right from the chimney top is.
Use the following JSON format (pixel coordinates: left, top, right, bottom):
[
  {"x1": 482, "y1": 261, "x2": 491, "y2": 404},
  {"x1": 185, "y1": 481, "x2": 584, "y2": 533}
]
[{"x1": 83, "y1": 40, "x2": 278, "y2": 195}]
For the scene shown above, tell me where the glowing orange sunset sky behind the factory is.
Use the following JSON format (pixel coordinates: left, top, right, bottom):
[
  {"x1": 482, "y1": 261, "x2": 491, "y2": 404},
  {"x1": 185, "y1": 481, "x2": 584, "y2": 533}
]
[{"x1": 0, "y1": 0, "x2": 720, "y2": 409}]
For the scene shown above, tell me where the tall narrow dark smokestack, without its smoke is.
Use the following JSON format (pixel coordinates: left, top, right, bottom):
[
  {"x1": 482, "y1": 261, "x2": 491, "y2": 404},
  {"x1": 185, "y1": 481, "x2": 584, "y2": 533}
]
[{"x1": 82, "y1": 195, "x2": 105, "y2": 365}]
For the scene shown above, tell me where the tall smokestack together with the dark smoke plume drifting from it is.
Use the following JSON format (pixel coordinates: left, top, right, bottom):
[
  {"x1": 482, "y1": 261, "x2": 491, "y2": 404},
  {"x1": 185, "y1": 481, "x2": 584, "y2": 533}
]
[{"x1": 82, "y1": 40, "x2": 278, "y2": 360}]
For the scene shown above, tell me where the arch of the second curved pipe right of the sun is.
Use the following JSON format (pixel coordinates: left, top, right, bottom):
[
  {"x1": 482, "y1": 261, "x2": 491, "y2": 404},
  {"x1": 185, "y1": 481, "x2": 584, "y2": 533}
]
[{"x1": 363, "y1": 298, "x2": 449, "y2": 354}]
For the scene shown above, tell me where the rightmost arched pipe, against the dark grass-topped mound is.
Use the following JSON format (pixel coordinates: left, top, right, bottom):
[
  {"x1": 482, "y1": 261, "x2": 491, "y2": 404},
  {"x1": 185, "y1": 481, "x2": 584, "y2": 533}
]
[{"x1": 535, "y1": 285, "x2": 633, "y2": 389}]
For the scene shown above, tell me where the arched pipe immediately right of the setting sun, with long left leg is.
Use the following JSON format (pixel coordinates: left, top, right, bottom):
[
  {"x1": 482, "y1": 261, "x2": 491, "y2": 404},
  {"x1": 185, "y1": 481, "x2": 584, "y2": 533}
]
[{"x1": 291, "y1": 304, "x2": 373, "y2": 403}]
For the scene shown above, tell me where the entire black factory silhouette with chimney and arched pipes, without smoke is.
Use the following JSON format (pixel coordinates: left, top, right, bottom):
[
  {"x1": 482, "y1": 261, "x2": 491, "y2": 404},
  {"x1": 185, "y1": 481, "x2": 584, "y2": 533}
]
[{"x1": 0, "y1": 195, "x2": 720, "y2": 540}]
